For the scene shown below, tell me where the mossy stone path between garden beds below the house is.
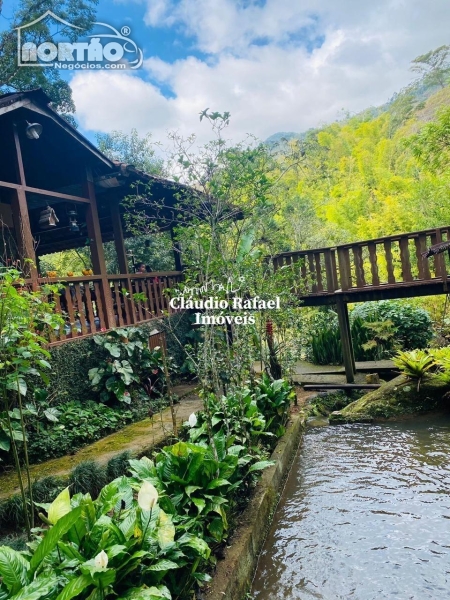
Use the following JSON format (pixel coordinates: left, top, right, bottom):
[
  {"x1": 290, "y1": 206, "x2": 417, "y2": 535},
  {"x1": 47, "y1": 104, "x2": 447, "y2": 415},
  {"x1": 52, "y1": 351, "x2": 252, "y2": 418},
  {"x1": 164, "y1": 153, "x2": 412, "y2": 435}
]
[{"x1": 0, "y1": 384, "x2": 203, "y2": 499}]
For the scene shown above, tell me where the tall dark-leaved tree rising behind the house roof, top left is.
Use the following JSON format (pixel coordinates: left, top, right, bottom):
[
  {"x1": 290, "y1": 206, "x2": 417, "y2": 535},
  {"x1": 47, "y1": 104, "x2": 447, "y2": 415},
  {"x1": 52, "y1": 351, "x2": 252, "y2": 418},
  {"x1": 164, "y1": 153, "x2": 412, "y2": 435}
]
[{"x1": 0, "y1": 0, "x2": 98, "y2": 122}]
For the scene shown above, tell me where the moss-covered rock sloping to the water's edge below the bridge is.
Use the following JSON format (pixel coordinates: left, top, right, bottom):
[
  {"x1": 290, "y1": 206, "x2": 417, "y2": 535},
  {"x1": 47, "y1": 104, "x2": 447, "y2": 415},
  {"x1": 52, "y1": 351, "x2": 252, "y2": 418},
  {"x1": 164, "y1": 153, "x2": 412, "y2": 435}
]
[{"x1": 330, "y1": 375, "x2": 450, "y2": 424}]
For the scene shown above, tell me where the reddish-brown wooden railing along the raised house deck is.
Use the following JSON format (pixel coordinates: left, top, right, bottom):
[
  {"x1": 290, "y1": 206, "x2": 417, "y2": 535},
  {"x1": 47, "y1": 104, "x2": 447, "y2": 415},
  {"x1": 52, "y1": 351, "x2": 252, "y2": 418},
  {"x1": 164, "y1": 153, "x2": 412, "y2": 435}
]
[{"x1": 38, "y1": 271, "x2": 182, "y2": 343}]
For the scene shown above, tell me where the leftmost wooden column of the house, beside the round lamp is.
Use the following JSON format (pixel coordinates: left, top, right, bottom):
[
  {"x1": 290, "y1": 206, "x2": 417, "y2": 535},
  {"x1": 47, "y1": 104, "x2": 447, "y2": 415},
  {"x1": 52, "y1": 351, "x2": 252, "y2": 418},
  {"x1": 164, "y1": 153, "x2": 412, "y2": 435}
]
[{"x1": 11, "y1": 124, "x2": 39, "y2": 289}]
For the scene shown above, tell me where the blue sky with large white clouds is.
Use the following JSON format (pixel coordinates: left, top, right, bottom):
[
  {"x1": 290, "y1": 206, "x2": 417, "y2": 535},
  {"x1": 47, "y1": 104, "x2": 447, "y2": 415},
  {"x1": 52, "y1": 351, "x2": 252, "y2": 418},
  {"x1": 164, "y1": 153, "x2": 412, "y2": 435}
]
[{"x1": 3, "y1": 0, "x2": 450, "y2": 141}]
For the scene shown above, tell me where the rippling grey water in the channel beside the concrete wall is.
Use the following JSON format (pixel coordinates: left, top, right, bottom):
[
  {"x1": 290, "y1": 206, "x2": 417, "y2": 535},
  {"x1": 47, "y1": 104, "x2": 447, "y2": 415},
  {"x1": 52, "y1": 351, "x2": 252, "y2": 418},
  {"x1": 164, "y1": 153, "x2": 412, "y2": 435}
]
[{"x1": 252, "y1": 416, "x2": 450, "y2": 600}]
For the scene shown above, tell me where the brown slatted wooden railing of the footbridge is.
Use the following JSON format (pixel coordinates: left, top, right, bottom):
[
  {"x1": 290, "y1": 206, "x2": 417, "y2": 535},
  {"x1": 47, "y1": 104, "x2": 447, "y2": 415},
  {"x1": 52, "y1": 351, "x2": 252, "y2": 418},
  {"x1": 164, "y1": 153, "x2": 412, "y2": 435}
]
[{"x1": 273, "y1": 226, "x2": 450, "y2": 295}]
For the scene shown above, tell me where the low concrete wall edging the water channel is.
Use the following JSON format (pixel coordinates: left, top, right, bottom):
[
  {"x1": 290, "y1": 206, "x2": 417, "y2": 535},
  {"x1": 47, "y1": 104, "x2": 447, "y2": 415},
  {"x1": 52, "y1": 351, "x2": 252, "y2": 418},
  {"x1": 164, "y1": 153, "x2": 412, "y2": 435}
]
[{"x1": 206, "y1": 412, "x2": 306, "y2": 600}]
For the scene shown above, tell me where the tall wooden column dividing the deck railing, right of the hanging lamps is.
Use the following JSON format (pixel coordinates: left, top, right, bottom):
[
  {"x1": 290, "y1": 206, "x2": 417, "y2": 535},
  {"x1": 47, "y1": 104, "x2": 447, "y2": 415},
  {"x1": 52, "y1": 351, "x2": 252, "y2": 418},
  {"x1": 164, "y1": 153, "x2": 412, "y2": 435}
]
[{"x1": 86, "y1": 168, "x2": 116, "y2": 329}]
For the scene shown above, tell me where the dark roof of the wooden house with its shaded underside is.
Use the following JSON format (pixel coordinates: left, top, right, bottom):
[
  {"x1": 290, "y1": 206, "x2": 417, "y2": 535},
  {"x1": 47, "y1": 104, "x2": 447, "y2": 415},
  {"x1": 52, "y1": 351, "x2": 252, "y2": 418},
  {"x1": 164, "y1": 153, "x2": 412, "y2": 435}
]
[{"x1": 0, "y1": 89, "x2": 236, "y2": 254}]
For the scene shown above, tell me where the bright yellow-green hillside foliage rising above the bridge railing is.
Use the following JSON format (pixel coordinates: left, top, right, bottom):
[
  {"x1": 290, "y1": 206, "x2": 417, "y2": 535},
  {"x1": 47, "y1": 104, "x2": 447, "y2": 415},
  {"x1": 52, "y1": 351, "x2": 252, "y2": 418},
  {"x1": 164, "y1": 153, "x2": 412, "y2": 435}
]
[{"x1": 277, "y1": 82, "x2": 450, "y2": 249}]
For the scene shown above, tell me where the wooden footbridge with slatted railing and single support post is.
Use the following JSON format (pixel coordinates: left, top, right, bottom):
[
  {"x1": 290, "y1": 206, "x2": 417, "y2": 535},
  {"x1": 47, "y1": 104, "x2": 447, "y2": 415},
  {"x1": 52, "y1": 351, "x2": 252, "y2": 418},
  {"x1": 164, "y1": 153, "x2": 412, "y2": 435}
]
[{"x1": 273, "y1": 227, "x2": 450, "y2": 383}]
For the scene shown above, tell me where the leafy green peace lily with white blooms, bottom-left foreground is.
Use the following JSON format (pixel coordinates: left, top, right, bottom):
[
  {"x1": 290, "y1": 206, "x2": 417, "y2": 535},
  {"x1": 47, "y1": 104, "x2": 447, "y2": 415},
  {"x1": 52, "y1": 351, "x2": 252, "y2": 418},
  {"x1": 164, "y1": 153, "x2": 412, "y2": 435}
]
[{"x1": 0, "y1": 477, "x2": 210, "y2": 600}]
